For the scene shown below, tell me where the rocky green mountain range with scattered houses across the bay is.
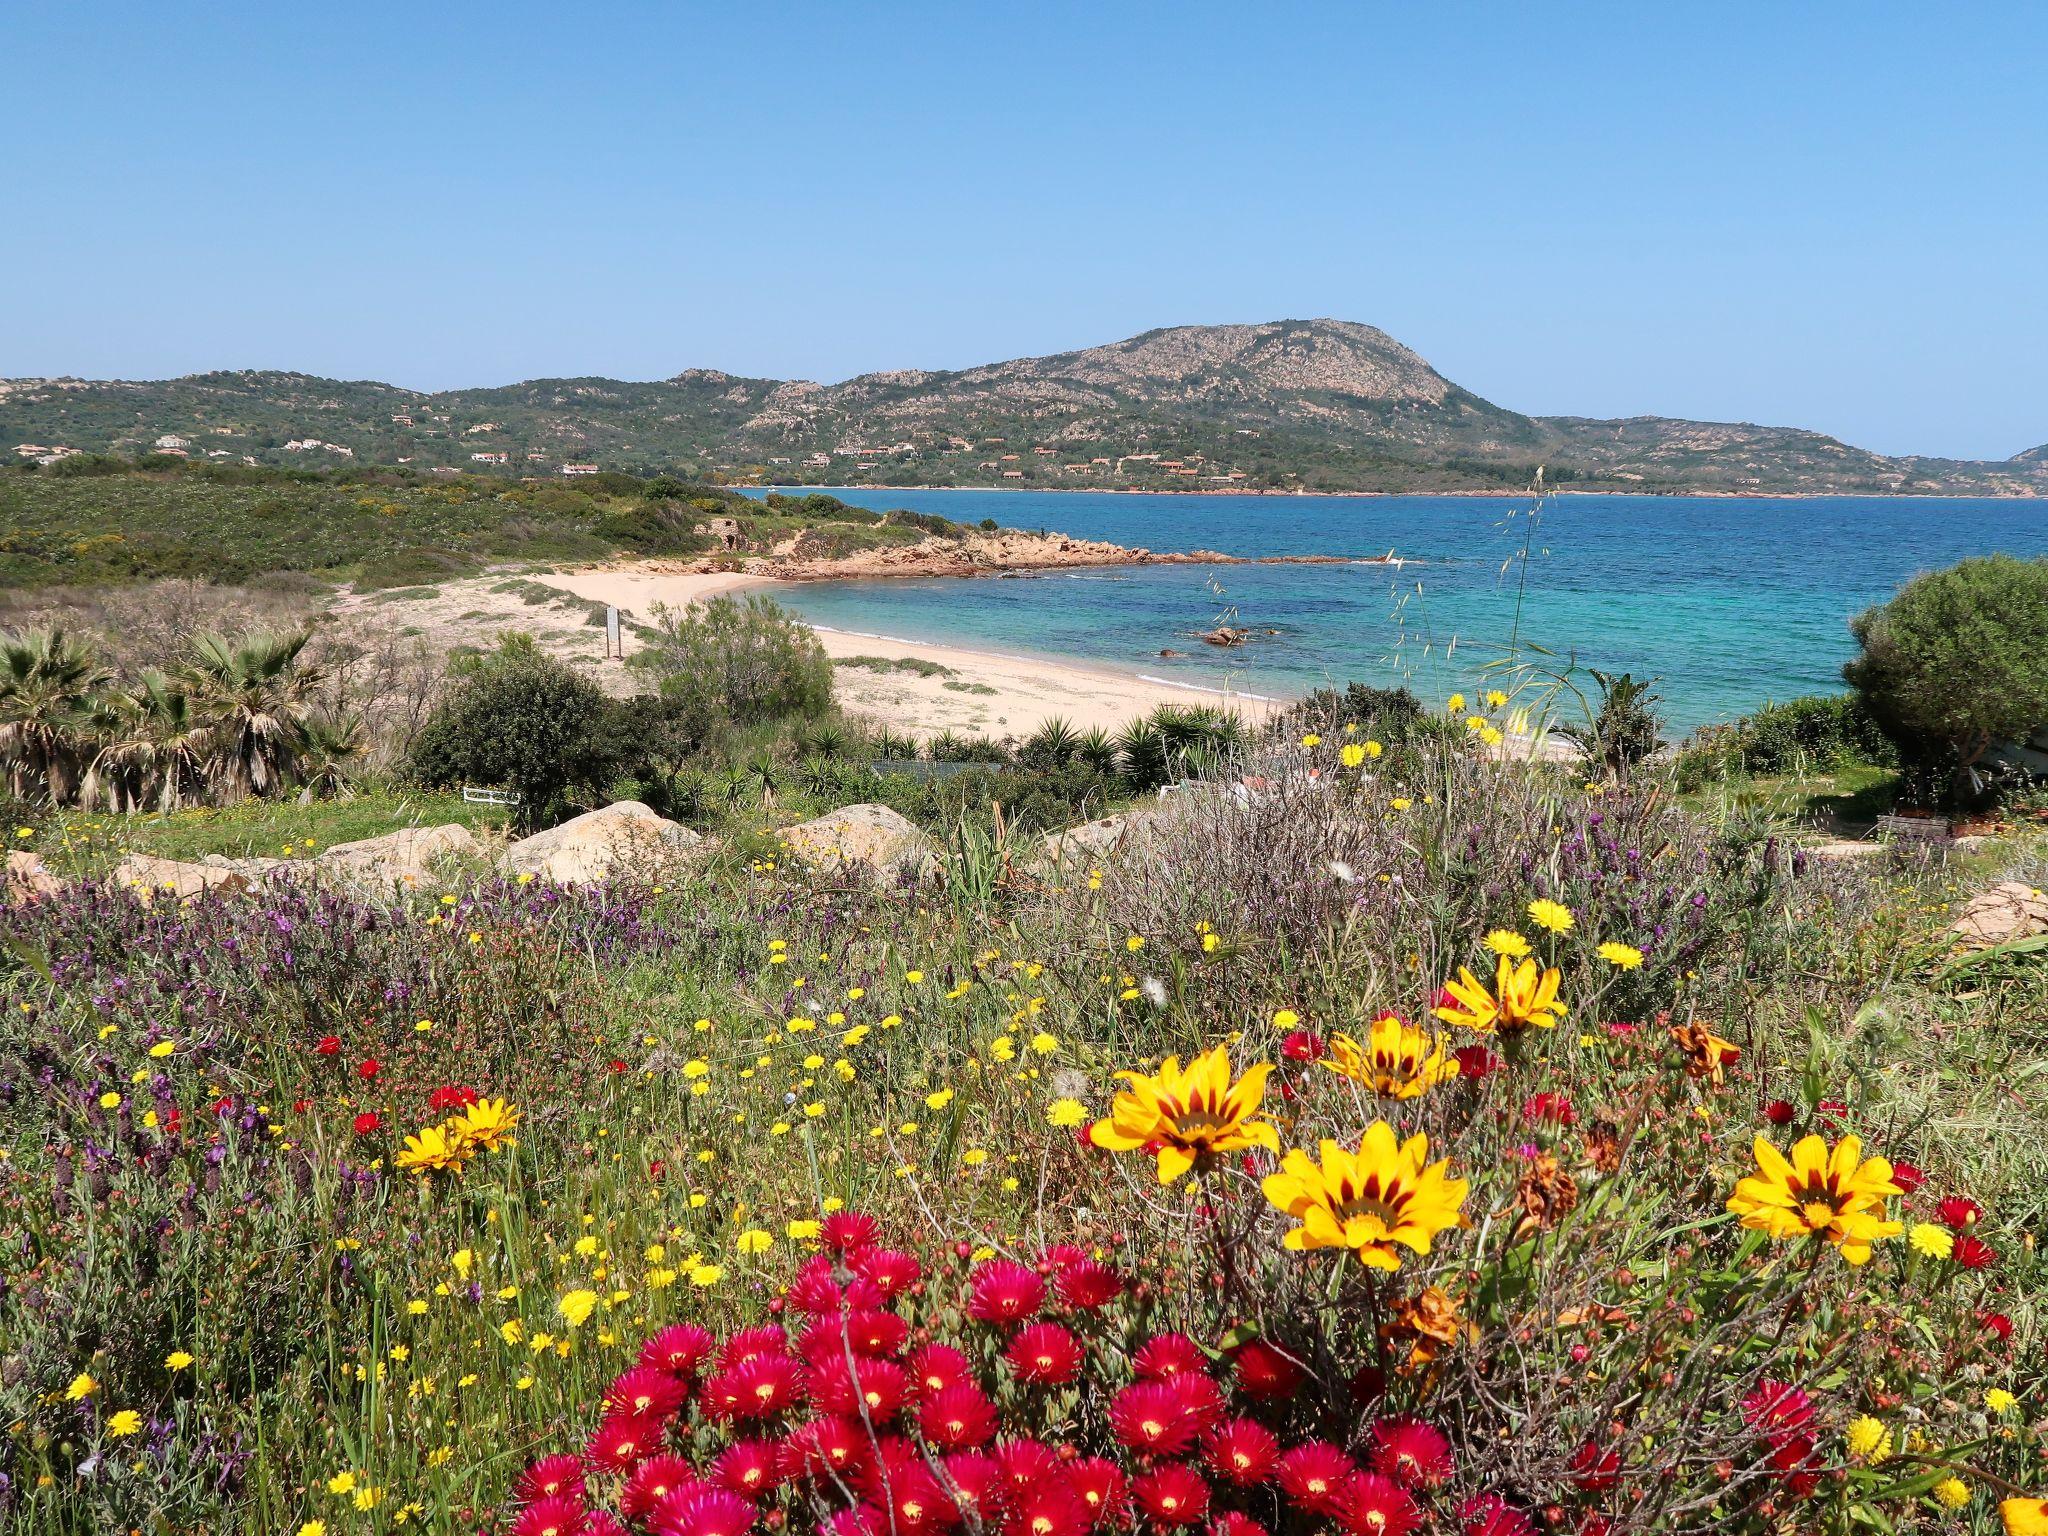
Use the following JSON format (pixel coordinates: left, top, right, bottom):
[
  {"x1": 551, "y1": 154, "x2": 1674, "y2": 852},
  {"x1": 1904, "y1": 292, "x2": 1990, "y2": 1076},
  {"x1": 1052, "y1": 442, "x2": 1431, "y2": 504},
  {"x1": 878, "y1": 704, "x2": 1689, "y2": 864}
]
[{"x1": 0, "y1": 319, "x2": 2048, "y2": 496}]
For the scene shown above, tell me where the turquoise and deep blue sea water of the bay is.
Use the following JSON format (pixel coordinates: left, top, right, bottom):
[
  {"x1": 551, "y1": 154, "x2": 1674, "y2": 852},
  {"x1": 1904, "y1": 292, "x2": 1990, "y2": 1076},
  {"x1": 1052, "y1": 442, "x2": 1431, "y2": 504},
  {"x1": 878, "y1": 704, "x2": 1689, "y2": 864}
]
[{"x1": 749, "y1": 487, "x2": 2048, "y2": 729}]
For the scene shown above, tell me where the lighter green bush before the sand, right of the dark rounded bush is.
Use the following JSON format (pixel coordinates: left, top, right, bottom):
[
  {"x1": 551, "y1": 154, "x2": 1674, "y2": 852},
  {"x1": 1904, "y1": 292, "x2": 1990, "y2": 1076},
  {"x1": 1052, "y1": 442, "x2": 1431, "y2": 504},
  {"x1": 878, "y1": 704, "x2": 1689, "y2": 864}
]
[{"x1": 633, "y1": 596, "x2": 831, "y2": 741}]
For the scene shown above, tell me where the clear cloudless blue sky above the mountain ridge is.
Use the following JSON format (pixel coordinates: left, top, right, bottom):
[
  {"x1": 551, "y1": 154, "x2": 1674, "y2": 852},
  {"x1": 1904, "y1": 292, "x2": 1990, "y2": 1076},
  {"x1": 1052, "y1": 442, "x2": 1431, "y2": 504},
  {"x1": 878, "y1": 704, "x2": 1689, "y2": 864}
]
[{"x1": 0, "y1": 0, "x2": 2048, "y2": 457}]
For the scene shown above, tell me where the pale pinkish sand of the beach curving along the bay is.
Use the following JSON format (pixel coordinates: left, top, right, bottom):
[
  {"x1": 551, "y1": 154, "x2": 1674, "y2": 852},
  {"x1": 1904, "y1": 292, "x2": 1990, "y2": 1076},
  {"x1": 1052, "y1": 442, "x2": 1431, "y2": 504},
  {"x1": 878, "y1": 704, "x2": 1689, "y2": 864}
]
[{"x1": 535, "y1": 561, "x2": 1274, "y2": 737}]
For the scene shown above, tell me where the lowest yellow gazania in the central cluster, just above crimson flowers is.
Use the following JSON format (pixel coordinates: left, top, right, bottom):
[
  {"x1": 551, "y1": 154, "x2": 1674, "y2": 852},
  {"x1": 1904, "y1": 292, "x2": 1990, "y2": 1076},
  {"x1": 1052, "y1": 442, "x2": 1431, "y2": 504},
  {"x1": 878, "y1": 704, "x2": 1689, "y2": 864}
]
[{"x1": 1264, "y1": 1120, "x2": 1470, "y2": 1270}]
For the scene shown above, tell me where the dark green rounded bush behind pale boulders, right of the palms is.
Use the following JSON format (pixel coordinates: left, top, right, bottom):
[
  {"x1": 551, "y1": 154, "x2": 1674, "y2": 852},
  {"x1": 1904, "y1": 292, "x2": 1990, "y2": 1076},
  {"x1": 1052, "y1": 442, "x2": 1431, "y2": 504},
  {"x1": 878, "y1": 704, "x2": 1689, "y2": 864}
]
[{"x1": 412, "y1": 635, "x2": 618, "y2": 829}]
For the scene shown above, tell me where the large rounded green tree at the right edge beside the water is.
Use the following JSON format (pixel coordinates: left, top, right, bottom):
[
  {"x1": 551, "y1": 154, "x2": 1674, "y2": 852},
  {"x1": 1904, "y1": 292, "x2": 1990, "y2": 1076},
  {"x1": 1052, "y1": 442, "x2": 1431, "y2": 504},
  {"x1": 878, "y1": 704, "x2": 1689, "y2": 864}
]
[{"x1": 1841, "y1": 555, "x2": 2048, "y2": 794}]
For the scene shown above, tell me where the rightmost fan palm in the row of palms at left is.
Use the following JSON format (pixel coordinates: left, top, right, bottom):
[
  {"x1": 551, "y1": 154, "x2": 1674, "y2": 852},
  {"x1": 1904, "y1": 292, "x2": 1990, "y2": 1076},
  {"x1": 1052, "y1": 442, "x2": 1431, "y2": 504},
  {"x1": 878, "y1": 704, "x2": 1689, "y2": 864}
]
[{"x1": 184, "y1": 631, "x2": 319, "y2": 799}]
